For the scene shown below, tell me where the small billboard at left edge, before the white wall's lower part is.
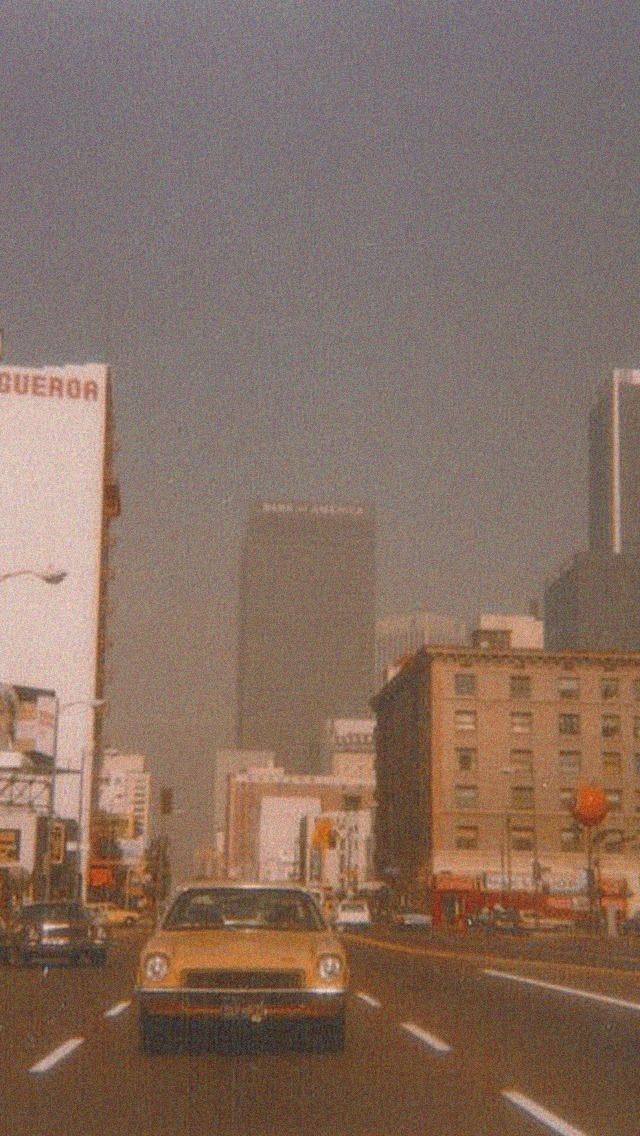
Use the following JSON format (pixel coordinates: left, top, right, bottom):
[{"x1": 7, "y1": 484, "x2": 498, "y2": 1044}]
[{"x1": 0, "y1": 683, "x2": 56, "y2": 767}]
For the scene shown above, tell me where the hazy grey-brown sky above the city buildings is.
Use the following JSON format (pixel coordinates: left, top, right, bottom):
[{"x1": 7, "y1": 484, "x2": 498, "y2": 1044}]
[{"x1": 0, "y1": 0, "x2": 640, "y2": 867}]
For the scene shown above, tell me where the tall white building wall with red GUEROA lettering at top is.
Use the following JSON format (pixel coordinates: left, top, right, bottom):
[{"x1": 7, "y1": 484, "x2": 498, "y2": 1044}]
[{"x1": 0, "y1": 364, "x2": 109, "y2": 824}]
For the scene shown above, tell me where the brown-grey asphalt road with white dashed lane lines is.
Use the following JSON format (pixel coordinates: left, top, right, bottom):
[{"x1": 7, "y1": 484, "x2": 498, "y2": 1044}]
[{"x1": 0, "y1": 929, "x2": 640, "y2": 1136}]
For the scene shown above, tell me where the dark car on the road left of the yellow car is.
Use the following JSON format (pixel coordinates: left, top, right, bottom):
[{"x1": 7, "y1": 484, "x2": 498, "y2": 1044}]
[{"x1": 8, "y1": 901, "x2": 107, "y2": 967}]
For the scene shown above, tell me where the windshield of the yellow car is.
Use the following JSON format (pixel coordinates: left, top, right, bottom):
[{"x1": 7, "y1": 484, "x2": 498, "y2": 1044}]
[{"x1": 163, "y1": 887, "x2": 324, "y2": 930}]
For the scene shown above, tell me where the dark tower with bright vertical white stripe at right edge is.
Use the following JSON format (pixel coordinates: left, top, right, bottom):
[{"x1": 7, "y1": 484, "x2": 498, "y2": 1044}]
[{"x1": 589, "y1": 370, "x2": 640, "y2": 554}]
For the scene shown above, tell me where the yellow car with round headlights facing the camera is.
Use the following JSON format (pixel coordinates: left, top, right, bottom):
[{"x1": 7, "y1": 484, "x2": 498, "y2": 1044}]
[{"x1": 135, "y1": 883, "x2": 348, "y2": 1052}]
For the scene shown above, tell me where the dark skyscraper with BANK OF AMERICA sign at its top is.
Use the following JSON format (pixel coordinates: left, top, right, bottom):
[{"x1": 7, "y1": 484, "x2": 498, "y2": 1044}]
[{"x1": 236, "y1": 501, "x2": 375, "y2": 772}]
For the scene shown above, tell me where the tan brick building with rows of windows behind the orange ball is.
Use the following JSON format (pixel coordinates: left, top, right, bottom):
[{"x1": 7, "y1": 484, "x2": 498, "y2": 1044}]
[{"x1": 372, "y1": 648, "x2": 640, "y2": 916}]
